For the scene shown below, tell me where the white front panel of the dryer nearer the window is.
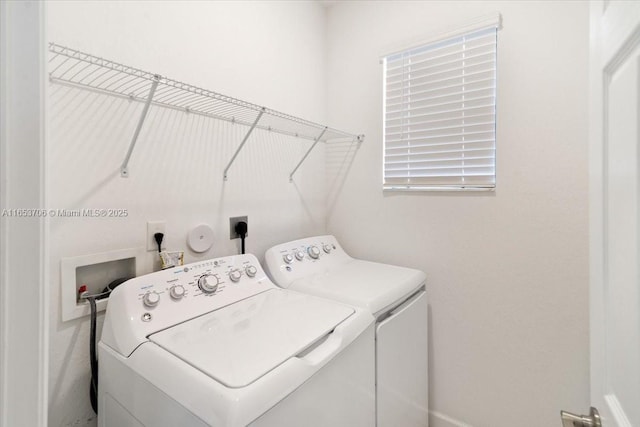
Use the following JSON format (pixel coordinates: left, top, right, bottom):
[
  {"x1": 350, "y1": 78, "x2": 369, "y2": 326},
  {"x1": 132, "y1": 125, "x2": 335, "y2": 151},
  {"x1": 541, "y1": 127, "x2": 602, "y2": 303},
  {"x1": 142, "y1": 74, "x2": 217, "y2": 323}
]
[{"x1": 376, "y1": 291, "x2": 429, "y2": 427}]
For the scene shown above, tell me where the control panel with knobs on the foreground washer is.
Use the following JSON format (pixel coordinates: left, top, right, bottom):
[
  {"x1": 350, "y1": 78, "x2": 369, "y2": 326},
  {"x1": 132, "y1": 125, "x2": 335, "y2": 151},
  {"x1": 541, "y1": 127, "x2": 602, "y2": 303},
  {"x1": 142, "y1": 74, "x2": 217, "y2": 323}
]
[{"x1": 101, "y1": 254, "x2": 277, "y2": 356}]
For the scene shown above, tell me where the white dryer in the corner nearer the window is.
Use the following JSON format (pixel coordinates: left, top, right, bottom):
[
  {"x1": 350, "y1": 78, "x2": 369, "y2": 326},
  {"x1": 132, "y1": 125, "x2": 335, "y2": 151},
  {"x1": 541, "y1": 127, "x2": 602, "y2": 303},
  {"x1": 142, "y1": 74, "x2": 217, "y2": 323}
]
[{"x1": 265, "y1": 236, "x2": 429, "y2": 427}]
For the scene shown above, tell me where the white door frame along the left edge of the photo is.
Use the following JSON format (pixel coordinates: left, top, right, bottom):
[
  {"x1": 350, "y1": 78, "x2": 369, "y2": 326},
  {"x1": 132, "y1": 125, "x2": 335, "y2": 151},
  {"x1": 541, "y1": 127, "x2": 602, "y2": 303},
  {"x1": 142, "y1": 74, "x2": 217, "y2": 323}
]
[{"x1": 0, "y1": 0, "x2": 49, "y2": 427}]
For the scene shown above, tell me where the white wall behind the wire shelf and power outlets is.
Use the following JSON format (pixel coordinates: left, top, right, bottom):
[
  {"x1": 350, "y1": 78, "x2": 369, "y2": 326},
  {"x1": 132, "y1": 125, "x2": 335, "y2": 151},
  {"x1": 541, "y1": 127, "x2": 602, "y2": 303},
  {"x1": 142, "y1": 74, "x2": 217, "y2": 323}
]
[{"x1": 48, "y1": 2, "x2": 326, "y2": 427}]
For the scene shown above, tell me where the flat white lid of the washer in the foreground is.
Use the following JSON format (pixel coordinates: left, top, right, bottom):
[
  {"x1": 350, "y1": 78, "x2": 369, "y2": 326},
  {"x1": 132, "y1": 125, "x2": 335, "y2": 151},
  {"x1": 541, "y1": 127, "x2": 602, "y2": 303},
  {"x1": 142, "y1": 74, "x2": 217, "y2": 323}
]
[{"x1": 149, "y1": 289, "x2": 355, "y2": 388}]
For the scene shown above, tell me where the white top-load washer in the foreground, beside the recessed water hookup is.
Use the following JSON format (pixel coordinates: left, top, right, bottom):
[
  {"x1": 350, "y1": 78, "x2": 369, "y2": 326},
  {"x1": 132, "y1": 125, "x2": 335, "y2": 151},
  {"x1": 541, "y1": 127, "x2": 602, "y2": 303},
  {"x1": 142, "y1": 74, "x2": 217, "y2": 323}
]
[{"x1": 98, "y1": 254, "x2": 375, "y2": 427}]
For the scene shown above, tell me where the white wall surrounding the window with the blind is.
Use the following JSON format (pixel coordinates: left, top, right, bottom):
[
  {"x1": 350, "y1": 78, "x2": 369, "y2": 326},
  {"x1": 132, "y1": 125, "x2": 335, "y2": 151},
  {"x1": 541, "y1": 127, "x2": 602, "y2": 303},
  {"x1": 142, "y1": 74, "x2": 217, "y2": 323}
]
[{"x1": 327, "y1": 1, "x2": 589, "y2": 427}]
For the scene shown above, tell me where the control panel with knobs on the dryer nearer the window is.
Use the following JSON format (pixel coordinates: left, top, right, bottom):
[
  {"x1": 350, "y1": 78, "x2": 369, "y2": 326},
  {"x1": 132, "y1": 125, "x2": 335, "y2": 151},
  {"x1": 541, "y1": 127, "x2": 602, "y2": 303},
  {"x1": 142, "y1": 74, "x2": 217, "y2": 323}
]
[{"x1": 264, "y1": 235, "x2": 353, "y2": 288}]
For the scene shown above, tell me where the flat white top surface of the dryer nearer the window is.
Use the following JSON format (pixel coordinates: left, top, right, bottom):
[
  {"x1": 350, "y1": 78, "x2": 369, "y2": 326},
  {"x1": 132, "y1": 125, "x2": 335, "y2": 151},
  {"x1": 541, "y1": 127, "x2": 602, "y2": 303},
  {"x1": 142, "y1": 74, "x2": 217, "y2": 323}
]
[{"x1": 289, "y1": 260, "x2": 427, "y2": 316}]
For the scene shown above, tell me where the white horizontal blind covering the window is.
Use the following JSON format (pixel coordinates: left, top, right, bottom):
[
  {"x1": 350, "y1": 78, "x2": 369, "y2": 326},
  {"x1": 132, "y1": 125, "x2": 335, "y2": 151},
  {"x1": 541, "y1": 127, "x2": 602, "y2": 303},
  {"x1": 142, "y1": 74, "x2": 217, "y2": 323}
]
[{"x1": 383, "y1": 27, "x2": 497, "y2": 190}]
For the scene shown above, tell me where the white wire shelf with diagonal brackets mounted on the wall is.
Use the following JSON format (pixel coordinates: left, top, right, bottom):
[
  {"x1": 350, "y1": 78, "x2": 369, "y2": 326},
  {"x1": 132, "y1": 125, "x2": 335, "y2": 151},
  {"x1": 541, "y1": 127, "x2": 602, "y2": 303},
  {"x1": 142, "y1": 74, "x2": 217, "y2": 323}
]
[{"x1": 49, "y1": 43, "x2": 364, "y2": 179}]
